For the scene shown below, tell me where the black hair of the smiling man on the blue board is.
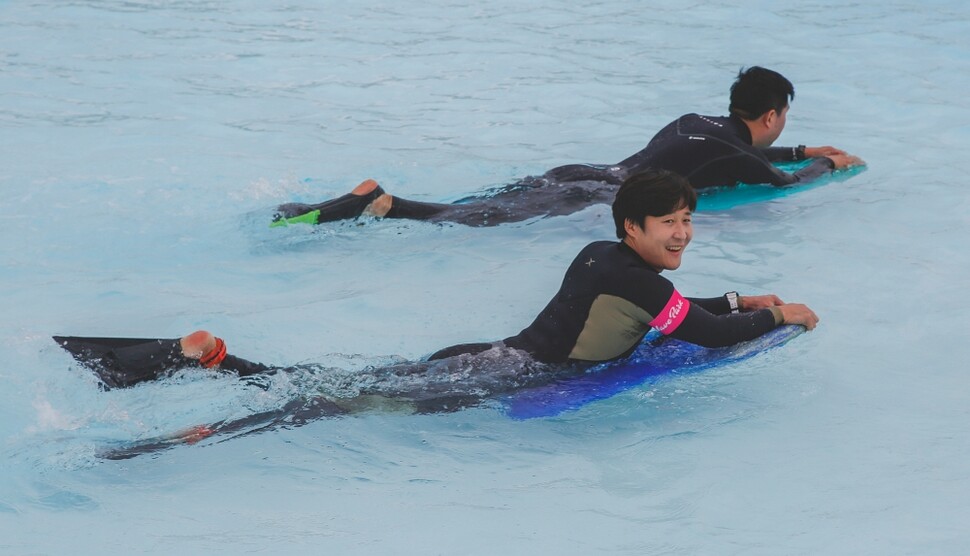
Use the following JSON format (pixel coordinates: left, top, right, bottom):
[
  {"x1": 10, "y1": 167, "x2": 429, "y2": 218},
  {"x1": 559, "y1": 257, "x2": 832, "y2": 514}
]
[{"x1": 613, "y1": 168, "x2": 697, "y2": 239}]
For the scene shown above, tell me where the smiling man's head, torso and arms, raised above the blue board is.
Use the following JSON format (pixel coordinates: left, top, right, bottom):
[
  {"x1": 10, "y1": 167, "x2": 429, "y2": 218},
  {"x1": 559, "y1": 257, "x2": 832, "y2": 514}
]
[{"x1": 492, "y1": 170, "x2": 818, "y2": 362}]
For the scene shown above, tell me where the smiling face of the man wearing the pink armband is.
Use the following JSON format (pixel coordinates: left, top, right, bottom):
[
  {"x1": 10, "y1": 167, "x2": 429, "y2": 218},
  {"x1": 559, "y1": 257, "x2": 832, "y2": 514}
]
[{"x1": 623, "y1": 207, "x2": 694, "y2": 272}]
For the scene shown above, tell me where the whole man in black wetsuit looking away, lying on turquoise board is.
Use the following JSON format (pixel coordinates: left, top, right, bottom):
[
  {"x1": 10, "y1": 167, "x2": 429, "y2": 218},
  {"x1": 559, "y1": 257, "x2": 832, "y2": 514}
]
[{"x1": 274, "y1": 66, "x2": 863, "y2": 226}]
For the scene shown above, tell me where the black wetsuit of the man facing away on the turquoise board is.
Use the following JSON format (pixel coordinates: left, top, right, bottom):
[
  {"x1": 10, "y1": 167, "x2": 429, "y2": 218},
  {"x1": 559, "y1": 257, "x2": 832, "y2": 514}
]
[{"x1": 277, "y1": 114, "x2": 834, "y2": 226}]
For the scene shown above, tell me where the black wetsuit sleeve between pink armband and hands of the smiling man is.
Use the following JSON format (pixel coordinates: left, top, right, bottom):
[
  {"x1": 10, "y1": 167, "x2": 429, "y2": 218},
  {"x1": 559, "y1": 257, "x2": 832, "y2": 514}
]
[{"x1": 670, "y1": 304, "x2": 778, "y2": 347}]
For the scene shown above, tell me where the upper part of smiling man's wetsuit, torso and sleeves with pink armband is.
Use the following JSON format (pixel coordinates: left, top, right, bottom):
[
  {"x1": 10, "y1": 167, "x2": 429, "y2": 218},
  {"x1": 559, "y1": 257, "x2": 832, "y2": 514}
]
[{"x1": 504, "y1": 241, "x2": 781, "y2": 363}]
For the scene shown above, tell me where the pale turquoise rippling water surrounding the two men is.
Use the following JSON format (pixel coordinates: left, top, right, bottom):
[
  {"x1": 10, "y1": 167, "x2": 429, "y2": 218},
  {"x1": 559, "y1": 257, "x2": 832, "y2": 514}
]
[{"x1": 0, "y1": 0, "x2": 970, "y2": 554}]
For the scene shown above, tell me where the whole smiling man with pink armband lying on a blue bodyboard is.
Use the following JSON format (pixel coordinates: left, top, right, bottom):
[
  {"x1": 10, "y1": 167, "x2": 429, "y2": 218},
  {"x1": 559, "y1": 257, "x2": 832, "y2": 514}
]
[{"x1": 89, "y1": 170, "x2": 818, "y2": 411}]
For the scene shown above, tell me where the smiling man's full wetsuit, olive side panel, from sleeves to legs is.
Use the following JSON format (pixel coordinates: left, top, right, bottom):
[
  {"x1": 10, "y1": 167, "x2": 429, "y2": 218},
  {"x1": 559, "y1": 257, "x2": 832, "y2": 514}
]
[{"x1": 74, "y1": 241, "x2": 781, "y2": 400}]
